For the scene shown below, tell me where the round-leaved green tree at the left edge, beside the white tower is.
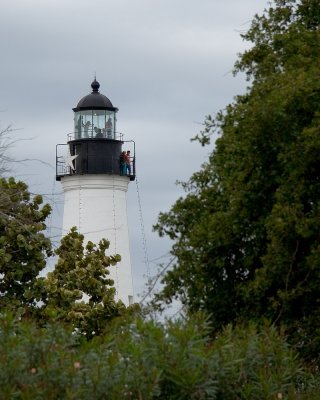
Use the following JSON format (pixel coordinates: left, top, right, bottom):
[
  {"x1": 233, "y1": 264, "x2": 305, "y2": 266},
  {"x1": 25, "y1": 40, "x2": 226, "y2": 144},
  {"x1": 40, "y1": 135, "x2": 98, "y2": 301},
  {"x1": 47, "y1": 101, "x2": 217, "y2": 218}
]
[{"x1": 0, "y1": 178, "x2": 52, "y2": 312}]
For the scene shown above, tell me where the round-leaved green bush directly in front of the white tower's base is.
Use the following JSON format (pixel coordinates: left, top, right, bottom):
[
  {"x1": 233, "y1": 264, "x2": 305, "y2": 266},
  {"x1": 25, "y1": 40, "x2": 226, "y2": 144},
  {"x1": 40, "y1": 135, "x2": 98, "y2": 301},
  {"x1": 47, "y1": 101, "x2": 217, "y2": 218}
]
[{"x1": 37, "y1": 228, "x2": 125, "y2": 338}]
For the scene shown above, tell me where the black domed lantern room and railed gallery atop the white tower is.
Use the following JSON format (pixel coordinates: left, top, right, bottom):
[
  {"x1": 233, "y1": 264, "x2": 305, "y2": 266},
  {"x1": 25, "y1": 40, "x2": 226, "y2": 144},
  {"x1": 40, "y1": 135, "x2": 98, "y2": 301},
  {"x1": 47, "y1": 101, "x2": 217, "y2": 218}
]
[{"x1": 56, "y1": 79, "x2": 135, "y2": 180}]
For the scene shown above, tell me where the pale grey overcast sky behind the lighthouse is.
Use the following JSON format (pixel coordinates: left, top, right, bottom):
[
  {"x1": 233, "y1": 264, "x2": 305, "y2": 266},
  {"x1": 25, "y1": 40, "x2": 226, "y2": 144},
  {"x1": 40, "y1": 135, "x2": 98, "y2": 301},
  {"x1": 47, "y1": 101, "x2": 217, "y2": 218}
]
[{"x1": 0, "y1": 0, "x2": 267, "y2": 304}]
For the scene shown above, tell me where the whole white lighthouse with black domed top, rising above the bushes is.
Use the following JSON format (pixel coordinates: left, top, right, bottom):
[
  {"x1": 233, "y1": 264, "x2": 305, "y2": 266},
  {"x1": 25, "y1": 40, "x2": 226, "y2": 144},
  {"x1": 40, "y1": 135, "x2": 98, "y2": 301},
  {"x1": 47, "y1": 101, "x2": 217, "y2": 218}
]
[{"x1": 56, "y1": 78, "x2": 135, "y2": 305}]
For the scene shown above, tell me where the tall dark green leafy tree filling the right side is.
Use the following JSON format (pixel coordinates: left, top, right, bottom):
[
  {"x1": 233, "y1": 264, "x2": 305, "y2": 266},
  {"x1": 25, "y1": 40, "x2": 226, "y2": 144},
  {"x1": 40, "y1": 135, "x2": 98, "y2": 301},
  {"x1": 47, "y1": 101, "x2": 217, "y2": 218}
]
[{"x1": 155, "y1": 0, "x2": 320, "y2": 355}]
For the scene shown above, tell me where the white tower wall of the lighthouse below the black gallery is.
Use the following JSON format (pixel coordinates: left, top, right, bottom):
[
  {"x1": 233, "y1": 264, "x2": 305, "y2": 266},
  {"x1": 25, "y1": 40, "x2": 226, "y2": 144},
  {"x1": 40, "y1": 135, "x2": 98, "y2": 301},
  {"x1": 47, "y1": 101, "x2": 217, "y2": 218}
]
[{"x1": 61, "y1": 174, "x2": 133, "y2": 305}]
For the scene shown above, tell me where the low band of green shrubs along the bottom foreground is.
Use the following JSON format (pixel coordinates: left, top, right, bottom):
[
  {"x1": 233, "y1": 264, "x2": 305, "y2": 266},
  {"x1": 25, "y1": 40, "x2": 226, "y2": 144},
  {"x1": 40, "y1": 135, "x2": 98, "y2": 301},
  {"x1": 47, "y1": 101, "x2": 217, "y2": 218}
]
[{"x1": 0, "y1": 315, "x2": 320, "y2": 400}]
